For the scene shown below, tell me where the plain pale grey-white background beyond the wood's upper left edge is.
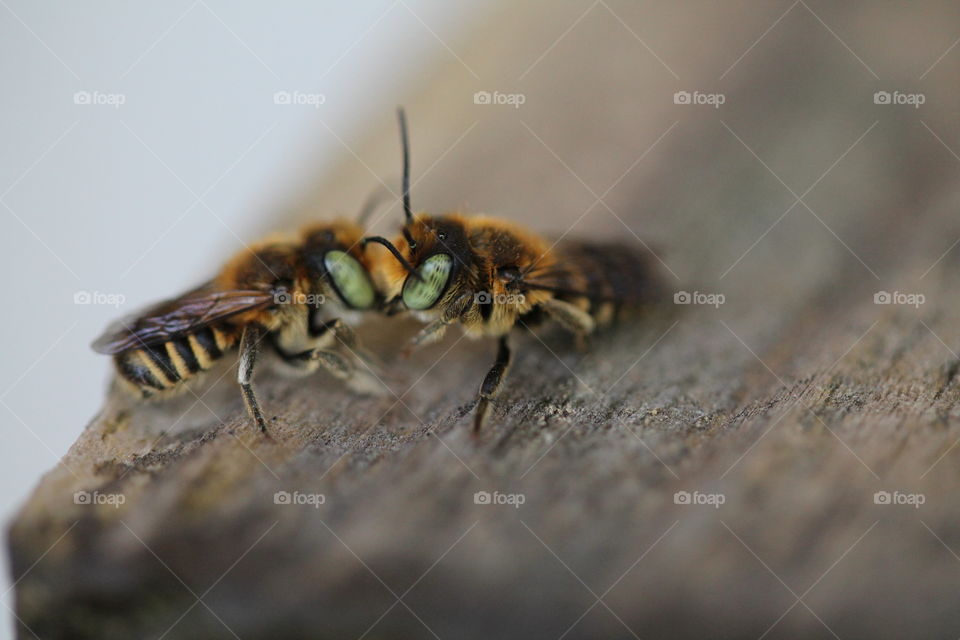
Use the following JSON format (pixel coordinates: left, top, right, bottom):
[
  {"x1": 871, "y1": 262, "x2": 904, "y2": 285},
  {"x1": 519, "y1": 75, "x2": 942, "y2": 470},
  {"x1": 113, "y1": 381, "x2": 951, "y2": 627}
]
[{"x1": 0, "y1": 0, "x2": 480, "y2": 637}]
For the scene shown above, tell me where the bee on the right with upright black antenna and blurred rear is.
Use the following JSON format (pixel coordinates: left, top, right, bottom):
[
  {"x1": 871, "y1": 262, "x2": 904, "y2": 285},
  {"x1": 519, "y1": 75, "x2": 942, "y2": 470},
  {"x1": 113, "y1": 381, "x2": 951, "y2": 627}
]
[{"x1": 364, "y1": 109, "x2": 659, "y2": 434}]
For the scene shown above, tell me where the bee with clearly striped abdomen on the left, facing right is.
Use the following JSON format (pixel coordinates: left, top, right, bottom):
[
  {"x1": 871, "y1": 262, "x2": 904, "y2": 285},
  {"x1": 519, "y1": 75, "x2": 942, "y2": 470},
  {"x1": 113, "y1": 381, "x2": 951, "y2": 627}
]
[{"x1": 93, "y1": 209, "x2": 382, "y2": 433}]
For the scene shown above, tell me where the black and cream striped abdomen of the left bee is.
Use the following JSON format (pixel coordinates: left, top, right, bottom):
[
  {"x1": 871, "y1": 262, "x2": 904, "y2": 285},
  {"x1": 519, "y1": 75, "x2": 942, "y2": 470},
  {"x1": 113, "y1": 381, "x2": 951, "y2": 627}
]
[{"x1": 114, "y1": 327, "x2": 238, "y2": 396}]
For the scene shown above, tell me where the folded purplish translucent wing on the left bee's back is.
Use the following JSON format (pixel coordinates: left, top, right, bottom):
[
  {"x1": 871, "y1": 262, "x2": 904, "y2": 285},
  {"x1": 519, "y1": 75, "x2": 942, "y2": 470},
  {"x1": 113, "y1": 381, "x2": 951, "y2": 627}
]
[{"x1": 92, "y1": 285, "x2": 274, "y2": 354}]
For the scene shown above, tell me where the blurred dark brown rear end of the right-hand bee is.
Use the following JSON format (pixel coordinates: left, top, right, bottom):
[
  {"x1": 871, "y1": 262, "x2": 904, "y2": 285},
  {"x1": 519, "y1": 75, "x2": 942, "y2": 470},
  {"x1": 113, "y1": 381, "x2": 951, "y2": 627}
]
[{"x1": 556, "y1": 242, "x2": 660, "y2": 324}]
